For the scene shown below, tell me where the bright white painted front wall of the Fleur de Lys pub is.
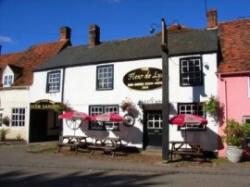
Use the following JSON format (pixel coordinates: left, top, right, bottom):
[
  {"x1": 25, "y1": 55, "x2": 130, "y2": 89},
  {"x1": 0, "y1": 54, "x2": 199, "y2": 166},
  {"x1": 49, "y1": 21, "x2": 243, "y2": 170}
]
[{"x1": 31, "y1": 53, "x2": 218, "y2": 150}]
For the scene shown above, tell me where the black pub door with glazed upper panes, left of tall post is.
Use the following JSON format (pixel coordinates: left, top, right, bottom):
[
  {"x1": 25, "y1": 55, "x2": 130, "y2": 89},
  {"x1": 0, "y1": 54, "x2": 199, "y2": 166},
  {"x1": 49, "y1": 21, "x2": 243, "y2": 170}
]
[{"x1": 145, "y1": 111, "x2": 162, "y2": 147}]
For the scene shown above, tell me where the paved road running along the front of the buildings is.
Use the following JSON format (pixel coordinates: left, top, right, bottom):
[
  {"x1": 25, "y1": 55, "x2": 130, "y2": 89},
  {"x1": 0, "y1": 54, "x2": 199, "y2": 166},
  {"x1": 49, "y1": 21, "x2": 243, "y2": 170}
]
[{"x1": 0, "y1": 145, "x2": 250, "y2": 187}]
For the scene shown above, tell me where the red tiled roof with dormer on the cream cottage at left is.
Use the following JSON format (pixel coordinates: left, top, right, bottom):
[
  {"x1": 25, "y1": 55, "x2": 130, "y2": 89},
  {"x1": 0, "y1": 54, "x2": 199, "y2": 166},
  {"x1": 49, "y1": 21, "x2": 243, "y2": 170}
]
[{"x1": 0, "y1": 41, "x2": 68, "y2": 87}]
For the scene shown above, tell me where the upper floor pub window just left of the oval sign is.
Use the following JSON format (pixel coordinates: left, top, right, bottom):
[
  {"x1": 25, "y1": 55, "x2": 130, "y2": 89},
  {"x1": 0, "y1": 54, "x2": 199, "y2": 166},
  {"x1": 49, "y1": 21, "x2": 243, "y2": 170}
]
[{"x1": 96, "y1": 65, "x2": 114, "y2": 90}]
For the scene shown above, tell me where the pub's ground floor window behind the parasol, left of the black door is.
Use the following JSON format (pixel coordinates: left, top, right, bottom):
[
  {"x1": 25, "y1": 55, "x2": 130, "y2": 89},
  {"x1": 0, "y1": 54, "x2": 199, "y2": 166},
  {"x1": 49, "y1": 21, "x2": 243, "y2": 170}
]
[{"x1": 89, "y1": 105, "x2": 119, "y2": 130}]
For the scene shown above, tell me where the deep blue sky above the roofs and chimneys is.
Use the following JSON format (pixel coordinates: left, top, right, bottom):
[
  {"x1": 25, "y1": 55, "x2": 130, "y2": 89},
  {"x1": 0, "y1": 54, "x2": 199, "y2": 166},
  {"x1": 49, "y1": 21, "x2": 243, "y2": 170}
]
[{"x1": 0, "y1": 0, "x2": 250, "y2": 54}]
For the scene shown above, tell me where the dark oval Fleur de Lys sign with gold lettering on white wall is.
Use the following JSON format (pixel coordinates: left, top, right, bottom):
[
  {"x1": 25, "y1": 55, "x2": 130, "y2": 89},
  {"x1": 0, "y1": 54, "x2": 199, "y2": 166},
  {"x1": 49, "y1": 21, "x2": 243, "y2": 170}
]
[{"x1": 123, "y1": 67, "x2": 162, "y2": 90}]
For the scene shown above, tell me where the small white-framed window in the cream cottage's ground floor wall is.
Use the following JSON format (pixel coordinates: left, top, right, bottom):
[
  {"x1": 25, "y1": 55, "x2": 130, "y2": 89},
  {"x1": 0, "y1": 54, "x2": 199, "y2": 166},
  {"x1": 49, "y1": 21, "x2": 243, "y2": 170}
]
[{"x1": 11, "y1": 108, "x2": 25, "y2": 127}]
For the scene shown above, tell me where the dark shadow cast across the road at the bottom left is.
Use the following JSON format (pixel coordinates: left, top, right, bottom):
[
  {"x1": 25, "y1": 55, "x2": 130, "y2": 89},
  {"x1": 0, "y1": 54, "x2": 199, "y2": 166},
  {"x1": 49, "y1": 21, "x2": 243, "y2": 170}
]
[{"x1": 0, "y1": 170, "x2": 167, "y2": 187}]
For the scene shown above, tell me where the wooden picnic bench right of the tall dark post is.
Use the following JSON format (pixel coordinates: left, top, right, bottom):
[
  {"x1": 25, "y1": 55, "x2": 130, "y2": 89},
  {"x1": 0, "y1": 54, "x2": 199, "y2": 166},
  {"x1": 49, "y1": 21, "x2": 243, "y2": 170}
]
[{"x1": 169, "y1": 141, "x2": 204, "y2": 161}]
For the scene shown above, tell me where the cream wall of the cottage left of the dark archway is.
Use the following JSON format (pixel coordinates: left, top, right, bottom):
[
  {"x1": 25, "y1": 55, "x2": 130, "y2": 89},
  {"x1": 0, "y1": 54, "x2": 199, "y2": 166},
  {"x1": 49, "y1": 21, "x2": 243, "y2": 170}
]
[{"x1": 0, "y1": 89, "x2": 30, "y2": 141}]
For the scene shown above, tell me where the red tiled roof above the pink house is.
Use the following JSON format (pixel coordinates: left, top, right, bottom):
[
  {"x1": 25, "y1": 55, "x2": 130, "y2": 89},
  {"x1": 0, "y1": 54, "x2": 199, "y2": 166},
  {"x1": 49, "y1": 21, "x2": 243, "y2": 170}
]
[{"x1": 219, "y1": 19, "x2": 250, "y2": 73}]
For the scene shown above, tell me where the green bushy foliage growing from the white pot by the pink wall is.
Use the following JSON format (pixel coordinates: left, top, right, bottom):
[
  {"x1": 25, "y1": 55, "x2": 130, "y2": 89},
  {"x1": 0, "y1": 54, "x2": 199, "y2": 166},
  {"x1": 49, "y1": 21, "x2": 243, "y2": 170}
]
[{"x1": 224, "y1": 120, "x2": 246, "y2": 147}]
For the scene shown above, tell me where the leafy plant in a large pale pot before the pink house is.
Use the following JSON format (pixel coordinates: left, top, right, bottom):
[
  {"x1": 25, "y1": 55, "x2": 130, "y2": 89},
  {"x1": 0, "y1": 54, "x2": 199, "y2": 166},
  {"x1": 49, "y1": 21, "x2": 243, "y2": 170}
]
[{"x1": 224, "y1": 120, "x2": 245, "y2": 163}]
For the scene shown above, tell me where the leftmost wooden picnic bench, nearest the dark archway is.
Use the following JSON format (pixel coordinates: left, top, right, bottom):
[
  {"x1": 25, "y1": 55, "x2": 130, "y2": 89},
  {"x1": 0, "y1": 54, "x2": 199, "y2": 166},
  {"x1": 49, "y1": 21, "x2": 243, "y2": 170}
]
[{"x1": 57, "y1": 136, "x2": 87, "y2": 153}]
